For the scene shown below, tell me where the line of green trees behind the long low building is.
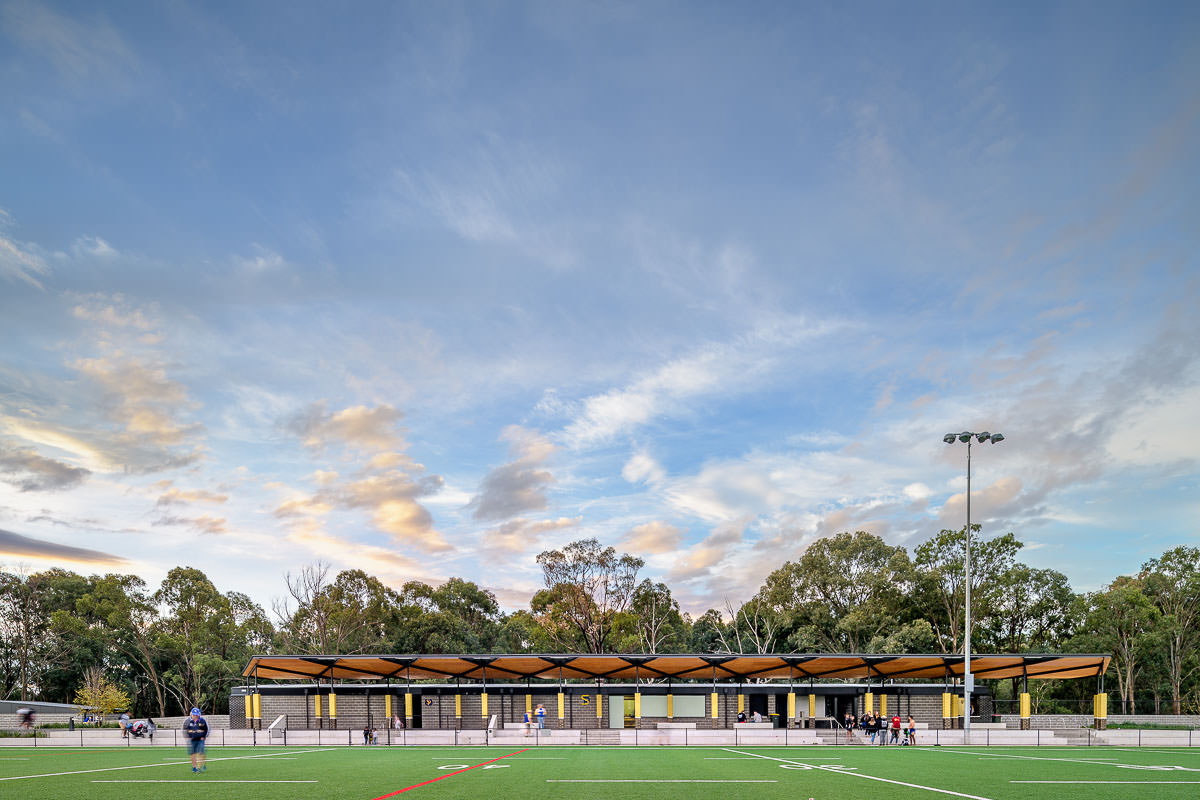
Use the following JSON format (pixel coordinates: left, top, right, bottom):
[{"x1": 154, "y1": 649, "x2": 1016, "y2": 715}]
[{"x1": 0, "y1": 530, "x2": 1200, "y2": 716}]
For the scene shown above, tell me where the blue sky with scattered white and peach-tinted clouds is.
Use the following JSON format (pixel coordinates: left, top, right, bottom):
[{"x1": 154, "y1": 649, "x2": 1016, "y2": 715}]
[{"x1": 0, "y1": 0, "x2": 1200, "y2": 614}]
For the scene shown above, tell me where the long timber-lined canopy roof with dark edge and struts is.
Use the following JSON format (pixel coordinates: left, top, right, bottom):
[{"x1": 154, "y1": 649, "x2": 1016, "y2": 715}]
[{"x1": 241, "y1": 654, "x2": 1110, "y2": 681}]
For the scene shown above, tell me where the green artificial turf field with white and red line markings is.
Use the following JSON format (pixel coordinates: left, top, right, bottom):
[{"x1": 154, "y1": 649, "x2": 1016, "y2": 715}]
[{"x1": 0, "y1": 746, "x2": 1200, "y2": 800}]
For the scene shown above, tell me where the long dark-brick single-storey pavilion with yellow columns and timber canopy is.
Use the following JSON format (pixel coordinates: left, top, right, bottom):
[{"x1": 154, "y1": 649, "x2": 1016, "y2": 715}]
[{"x1": 236, "y1": 654, "x2": 1110, "y2": 730}]
